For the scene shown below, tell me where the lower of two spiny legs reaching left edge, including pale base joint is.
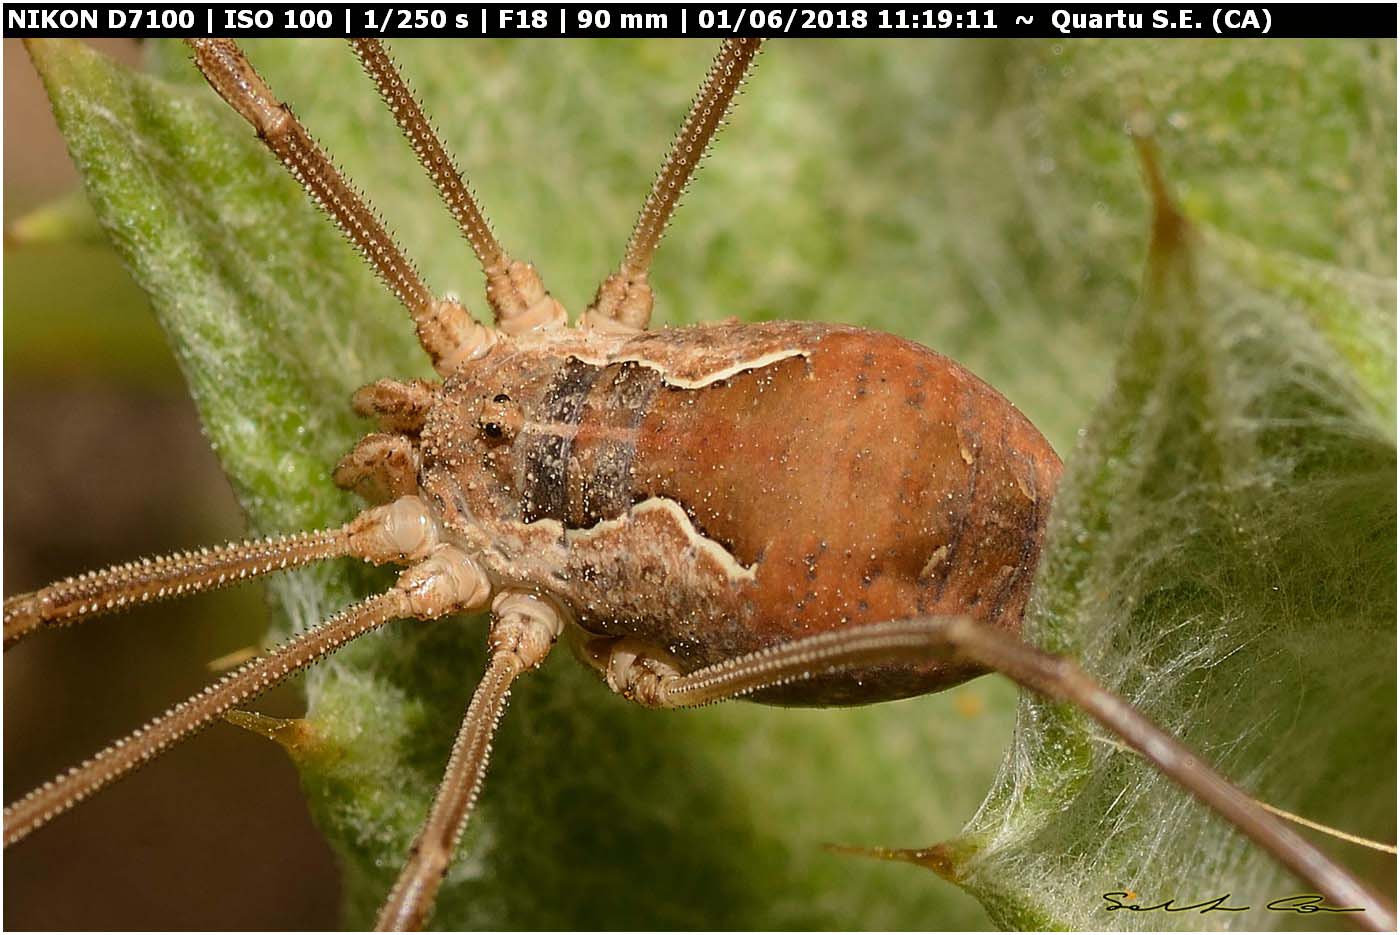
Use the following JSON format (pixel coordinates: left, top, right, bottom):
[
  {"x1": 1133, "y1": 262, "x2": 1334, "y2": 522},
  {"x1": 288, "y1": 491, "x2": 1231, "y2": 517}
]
[{"x1": 4, "y1": 546, "x2": 490, "y2": 847}]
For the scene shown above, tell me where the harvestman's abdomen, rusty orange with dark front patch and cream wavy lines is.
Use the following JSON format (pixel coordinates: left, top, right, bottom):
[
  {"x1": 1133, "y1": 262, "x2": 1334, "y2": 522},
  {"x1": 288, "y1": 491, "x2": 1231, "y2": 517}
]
[{"x1": 492, "y1": 322, "x2": 1060, "y2": 704}]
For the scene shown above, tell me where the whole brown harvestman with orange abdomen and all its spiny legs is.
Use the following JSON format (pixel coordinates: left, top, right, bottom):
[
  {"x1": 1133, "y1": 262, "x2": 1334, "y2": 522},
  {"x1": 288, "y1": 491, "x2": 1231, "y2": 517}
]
[{"x1": 4, "y1": 39, "x2": 1394, "y2": 929}]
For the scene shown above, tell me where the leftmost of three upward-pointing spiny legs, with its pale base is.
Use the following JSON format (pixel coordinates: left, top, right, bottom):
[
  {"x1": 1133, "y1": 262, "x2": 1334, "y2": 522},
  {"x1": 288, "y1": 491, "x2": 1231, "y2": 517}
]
[{"x1": 186, "y1": 39, "x2": 494, "y2": 377}]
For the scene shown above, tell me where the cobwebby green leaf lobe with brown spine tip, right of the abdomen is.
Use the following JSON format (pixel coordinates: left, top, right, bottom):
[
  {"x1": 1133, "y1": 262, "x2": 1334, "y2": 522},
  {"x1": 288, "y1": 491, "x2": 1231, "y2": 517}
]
[{"x1": 941, "y1": 184, "x2": 1396, "y2": 929}]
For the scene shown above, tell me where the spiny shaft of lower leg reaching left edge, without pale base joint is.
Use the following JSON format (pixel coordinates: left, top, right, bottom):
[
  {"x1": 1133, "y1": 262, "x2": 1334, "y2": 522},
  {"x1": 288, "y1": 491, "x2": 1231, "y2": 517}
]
[{"x1": 4, "y1": 588, "x2": 412, "y2": 847}]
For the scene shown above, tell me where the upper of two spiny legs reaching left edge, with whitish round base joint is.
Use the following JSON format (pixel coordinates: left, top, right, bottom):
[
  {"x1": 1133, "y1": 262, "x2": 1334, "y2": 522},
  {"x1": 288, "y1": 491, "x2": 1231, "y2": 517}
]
[{"x1": 4, "y1": 497, "x2": 437, "y2": 649}]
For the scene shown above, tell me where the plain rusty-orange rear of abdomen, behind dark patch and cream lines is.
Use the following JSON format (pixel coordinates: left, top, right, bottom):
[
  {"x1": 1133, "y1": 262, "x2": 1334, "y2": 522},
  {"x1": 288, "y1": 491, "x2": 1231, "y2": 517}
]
[{"x1": 631, "y1": 329, "x2": 1060, "y2": 704}]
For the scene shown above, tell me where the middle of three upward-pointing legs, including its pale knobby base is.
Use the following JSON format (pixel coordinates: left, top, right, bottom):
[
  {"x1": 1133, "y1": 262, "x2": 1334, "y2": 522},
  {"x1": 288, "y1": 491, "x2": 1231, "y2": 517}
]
[{"x1": 350, "y1": 39, "x2": 567, "y2": 335}]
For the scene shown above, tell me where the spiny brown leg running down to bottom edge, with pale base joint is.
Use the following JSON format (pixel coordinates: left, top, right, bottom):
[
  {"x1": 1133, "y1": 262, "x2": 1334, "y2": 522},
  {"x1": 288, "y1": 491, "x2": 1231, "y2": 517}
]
[{"x1": 375, "y1": 592, "x2": 563, "y2": 932}]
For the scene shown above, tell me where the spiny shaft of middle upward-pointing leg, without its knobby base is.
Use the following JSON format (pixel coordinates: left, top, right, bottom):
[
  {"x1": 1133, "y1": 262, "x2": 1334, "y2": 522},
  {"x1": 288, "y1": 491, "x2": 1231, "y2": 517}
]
[{"x1": 349, "y1": 39, "x2": 507, "y2": 272}]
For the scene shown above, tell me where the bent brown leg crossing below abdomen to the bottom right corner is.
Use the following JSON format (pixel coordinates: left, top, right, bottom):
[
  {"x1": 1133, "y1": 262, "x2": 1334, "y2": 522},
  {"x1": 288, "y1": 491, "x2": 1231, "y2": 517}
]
[{"x1": 608, "y1": 617, "x2": 1396, "y2": 929}]
